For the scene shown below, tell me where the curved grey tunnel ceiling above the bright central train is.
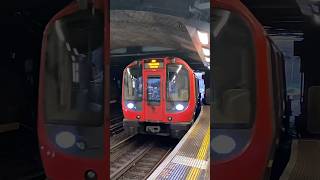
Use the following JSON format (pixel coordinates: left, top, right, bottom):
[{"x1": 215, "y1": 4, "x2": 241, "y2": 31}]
[{"x1": 110, "y1": 0, "x2": 210, "y2": 71}]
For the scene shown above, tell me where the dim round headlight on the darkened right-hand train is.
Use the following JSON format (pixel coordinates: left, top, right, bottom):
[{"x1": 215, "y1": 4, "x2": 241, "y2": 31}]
[{"x1": 211, "y1": 135, "x2": 236, "y2": 154}]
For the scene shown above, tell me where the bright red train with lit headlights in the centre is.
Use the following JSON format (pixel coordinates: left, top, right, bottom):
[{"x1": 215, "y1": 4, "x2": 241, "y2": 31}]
[{"x1": 122, "y1": 57, "x2": 200, "y2": 138}]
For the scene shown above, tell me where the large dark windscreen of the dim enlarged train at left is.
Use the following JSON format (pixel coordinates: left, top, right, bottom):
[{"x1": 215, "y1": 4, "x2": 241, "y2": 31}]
[{"x1": 45, "y1": 11, "x2": 104, "y2": 126}]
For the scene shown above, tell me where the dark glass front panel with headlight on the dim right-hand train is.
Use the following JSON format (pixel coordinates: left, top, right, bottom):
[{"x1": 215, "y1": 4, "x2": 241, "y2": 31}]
[{"x1": 211, "y1": 8, "x2": 255, "y2": 161}]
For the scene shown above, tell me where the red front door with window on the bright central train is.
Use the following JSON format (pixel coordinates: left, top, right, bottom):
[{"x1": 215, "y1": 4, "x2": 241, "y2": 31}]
[{"x1": 144, "y1": 70, "x2": 165, "y2": 125}]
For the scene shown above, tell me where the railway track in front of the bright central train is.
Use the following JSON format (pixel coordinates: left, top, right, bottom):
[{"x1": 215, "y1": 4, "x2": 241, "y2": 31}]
[{"x1": 110, "y1": 135, "x2": 177, "y2": 180}]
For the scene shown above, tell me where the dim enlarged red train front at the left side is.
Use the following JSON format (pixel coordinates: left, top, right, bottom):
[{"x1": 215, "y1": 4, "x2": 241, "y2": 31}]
[{"x1": 38, "y1": 1, "x2": 108, "y2": 180}]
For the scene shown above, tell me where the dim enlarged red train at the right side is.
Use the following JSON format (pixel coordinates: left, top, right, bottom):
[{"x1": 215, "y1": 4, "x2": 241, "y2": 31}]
[{"x1": 210, "y1": 0, "x2": 288, "y2": 180}]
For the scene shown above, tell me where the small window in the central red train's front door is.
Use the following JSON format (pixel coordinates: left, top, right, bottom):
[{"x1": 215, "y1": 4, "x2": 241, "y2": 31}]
[{"x1": 147, "y1": 77, "x2": 161, "y2": 102}]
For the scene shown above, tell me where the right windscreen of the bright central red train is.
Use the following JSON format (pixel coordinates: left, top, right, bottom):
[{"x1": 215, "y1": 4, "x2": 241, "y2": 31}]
[{"x1": 167, "y1": 64, "x2": 189, "y2": 101}]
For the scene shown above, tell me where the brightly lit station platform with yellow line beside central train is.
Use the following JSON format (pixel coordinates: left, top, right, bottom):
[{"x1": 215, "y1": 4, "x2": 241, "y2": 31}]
[{"x1": 148, "y1": 106, "x2": 210, "y2": 180}]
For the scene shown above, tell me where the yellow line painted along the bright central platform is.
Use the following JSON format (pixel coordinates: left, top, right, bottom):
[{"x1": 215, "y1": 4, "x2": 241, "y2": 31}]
[{"x1": 186, "y1": 126, "x2": 210, "y2": 180}]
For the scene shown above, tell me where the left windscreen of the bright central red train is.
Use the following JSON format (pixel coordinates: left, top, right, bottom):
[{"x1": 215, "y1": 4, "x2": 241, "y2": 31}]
[{"x1": 124, "y1": 65, "x2": 142, "y2": 101}]
